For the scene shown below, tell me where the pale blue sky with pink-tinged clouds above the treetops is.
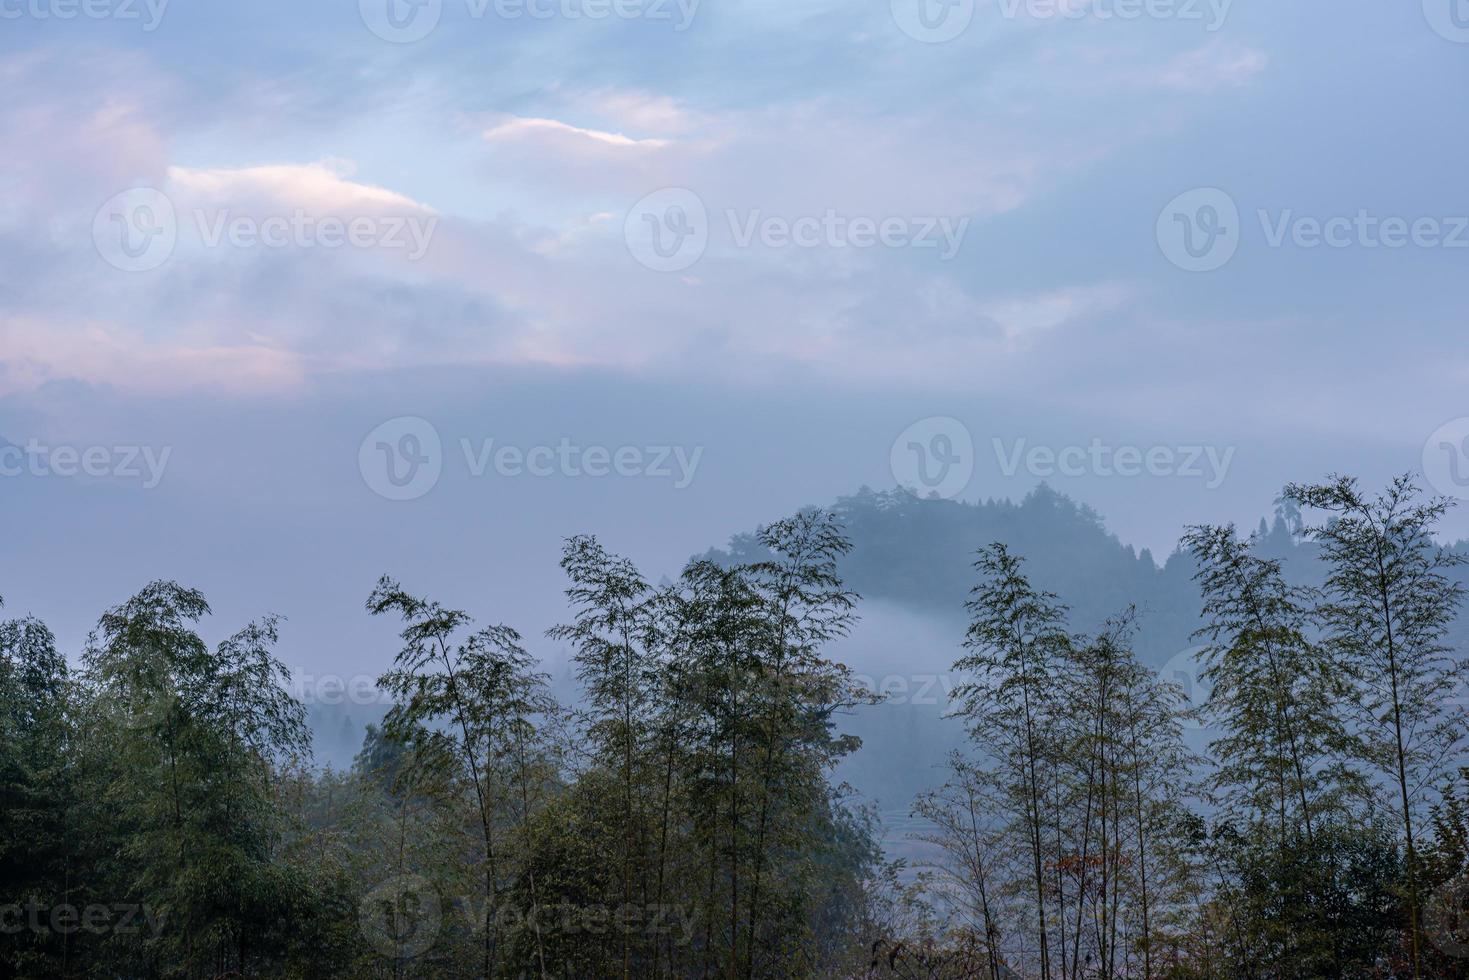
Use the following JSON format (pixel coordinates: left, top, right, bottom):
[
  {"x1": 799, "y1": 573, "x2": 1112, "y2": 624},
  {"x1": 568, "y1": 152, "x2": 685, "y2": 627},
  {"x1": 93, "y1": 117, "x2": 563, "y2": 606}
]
[{"x1": 0, "y1": 0, "x2": 1469, "y2": 687}]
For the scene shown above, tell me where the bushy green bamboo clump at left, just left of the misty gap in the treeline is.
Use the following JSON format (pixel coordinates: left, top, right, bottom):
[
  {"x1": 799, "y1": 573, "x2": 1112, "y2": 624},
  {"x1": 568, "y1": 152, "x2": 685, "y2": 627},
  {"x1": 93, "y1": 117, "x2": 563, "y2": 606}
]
[{"x1": 84, "y1": 582, "x2": 308, "y2": 974}]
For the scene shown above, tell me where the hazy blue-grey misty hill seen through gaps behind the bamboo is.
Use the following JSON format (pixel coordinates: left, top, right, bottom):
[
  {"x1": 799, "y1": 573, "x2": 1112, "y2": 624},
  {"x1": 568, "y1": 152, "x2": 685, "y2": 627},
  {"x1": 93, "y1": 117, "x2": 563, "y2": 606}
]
[{"x1": 311, "y1": 485, "x2": 1469, "y2": 828}]
